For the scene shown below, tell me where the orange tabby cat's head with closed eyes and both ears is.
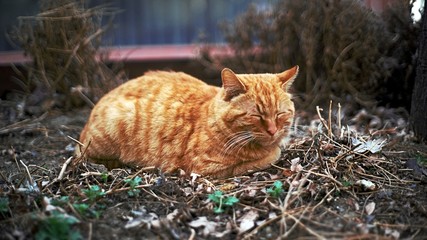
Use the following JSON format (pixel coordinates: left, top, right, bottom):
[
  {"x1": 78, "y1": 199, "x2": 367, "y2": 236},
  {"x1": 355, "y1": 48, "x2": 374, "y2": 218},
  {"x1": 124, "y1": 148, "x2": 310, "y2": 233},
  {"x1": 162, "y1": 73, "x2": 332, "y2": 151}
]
[{"x1": 219, "y1": 66, "x2": 298, "y2": 145}]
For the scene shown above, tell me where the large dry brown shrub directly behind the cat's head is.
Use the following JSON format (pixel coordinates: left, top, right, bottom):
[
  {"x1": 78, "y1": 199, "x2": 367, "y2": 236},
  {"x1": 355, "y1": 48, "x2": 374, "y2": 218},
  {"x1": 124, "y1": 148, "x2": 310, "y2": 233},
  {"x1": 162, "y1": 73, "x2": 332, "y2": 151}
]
[{"x1": 204, "y1": 0, "x2": 418, "y2": 109}]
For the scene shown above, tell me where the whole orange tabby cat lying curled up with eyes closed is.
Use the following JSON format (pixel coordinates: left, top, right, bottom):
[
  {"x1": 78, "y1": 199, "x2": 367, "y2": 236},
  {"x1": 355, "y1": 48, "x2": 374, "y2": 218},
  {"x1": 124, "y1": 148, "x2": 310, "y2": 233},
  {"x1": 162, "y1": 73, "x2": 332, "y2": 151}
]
[{"x1": 80, "y1": 66, "x2": 298, "y2": 177}]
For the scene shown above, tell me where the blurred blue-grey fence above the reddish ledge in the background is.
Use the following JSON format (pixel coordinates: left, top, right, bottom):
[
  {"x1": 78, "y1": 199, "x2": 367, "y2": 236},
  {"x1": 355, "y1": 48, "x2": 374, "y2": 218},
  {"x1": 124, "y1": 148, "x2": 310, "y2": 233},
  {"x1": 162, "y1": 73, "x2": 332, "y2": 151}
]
[{"x1": 0, "y1": 0, "x2": 275, "y2": 51}]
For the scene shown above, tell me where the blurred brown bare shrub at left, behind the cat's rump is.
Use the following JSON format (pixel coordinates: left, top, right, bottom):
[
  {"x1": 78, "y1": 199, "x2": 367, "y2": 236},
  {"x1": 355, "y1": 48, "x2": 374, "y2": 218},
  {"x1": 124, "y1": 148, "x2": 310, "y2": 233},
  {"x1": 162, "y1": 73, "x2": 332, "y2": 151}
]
[{"x1": 12, "y1": 0, "x2": 123, "y2": 112}]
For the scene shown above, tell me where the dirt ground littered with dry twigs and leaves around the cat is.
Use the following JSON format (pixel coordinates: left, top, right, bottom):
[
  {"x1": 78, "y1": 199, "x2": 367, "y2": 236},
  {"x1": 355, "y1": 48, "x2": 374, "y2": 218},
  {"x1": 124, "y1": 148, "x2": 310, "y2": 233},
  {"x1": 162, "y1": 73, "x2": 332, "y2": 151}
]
[{"x1": 0, "y1": 107, "x2": 427, "y2": 239}]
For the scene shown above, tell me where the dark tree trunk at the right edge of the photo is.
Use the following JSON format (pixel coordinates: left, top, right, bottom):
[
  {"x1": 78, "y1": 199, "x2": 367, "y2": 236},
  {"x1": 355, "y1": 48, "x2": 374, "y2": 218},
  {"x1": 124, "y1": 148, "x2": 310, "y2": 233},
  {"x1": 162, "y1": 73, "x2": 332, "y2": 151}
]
[{"x1": 409, "y1": 7, "x2": 427, "y2": 141}]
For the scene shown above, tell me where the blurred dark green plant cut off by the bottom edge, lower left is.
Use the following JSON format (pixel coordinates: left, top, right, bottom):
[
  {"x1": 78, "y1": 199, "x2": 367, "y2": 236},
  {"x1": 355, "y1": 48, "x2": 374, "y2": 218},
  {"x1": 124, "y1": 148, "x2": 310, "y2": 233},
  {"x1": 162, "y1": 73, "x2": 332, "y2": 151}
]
[{"x1": 35, "y1": 212, "x2": 82, "y2": 240}]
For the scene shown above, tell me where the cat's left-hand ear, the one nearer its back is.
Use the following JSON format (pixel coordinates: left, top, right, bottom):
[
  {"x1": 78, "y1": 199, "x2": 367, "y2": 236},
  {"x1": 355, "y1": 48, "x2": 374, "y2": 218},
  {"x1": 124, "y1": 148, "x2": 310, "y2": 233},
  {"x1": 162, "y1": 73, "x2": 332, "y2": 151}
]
[{"x1": 221, "y1": 68, "x2": 246, "y2": 101}]
